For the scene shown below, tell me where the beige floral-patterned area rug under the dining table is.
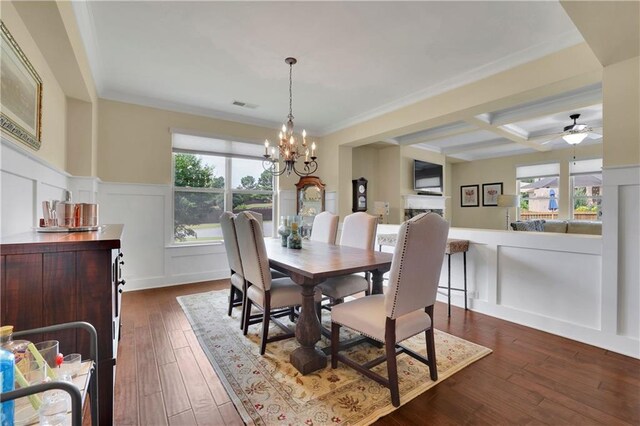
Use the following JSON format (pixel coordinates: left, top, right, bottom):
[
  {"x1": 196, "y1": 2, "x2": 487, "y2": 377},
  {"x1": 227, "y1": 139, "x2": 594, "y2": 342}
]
[{"x1": 178, "y1": 291, "x2": 491, "y2": 425}]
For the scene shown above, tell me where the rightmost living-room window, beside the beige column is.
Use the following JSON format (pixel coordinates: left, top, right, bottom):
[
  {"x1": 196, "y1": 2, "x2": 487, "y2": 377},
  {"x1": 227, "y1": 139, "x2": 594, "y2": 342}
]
[{"x1": 569, "y1": 158, "x2": 602, "y2": 220}]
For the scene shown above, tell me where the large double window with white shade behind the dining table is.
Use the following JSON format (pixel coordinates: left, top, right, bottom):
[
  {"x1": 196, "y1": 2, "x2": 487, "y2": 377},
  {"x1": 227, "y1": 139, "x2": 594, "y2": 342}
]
[{"x1": 173, "y1": 133, "x2": 274, "y2": 243}]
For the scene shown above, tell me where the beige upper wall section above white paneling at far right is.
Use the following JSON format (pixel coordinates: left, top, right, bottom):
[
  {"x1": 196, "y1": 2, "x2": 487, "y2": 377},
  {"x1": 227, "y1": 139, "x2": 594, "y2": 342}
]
[{"x1": 602, "y1": 57, "x2": 640, "y2": 167}]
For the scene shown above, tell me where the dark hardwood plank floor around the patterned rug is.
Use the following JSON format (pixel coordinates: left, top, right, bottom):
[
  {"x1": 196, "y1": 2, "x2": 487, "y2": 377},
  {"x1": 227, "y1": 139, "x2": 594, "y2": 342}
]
[{"x1": 115, "y1": 281, "x2": 640, "y2": 426}]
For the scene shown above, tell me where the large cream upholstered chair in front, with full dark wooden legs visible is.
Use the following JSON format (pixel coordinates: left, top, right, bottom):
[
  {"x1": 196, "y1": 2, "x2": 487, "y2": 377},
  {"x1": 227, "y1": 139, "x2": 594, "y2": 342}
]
[{"x1": 331, "y1": 213, "x2": 449, "y2": 407}]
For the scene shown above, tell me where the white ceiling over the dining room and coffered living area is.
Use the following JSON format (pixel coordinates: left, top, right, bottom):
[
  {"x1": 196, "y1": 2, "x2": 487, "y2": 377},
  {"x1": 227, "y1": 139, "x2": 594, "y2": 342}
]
[{"x1": 73, "y1": 1, "x2": 602, "y2": 160}]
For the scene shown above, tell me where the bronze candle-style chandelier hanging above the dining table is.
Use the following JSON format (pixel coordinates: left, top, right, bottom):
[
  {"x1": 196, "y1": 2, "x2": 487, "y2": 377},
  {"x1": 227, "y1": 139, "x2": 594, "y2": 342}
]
[{"x1": 262, "y1": 58, "x2": 318, "y2": 176}]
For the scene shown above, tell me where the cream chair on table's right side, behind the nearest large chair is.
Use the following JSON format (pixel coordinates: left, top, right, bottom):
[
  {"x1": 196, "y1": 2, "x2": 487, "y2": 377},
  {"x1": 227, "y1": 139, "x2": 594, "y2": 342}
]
[{"x1": 318, "y1": 212, "x2": 378, "y2": 305}]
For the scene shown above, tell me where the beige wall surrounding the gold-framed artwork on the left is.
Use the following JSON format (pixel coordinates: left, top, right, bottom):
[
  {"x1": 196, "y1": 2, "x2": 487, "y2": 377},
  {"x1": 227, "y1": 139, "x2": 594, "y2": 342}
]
[{"x1": 0, "y1": 1, "x2": 67, "y2": 170}]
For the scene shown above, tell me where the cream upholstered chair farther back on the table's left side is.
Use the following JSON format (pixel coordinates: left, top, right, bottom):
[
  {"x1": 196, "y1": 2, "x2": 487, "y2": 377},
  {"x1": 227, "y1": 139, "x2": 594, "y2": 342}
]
[{"x1": 220, "y1": 212, "x2": 286, "y2": 329}]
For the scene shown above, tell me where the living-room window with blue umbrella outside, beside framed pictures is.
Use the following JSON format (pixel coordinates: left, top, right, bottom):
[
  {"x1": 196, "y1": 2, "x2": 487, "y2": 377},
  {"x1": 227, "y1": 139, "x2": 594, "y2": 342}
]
[{"x1": 516, "y1": 163, "x2": 560, "y2": 220}]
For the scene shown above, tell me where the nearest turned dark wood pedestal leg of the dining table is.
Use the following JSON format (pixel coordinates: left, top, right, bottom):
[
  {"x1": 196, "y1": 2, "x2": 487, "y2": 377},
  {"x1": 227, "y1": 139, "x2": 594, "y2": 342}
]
[{"x1": 290, "y1": 284, "x2": 327, "y2": 375}]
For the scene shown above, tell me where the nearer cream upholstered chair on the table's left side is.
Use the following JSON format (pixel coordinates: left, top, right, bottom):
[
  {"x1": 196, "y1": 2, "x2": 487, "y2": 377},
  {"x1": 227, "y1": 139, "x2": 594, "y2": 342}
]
[{"x1": 234, "y1": 212, "x2": 322, "y2": 355}]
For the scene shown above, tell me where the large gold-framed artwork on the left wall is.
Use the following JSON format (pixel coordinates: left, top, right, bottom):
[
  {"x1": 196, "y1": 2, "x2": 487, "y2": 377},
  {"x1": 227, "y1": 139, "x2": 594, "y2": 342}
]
[{"x1": 0, "y1": 21, "x2": 42, "y2": 150}]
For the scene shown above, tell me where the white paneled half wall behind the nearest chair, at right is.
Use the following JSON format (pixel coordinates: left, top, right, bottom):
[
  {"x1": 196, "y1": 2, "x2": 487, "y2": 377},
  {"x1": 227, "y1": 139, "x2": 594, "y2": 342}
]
[{"x1": 378, "y1": 223, "x2": 640, "y2": 358}]
